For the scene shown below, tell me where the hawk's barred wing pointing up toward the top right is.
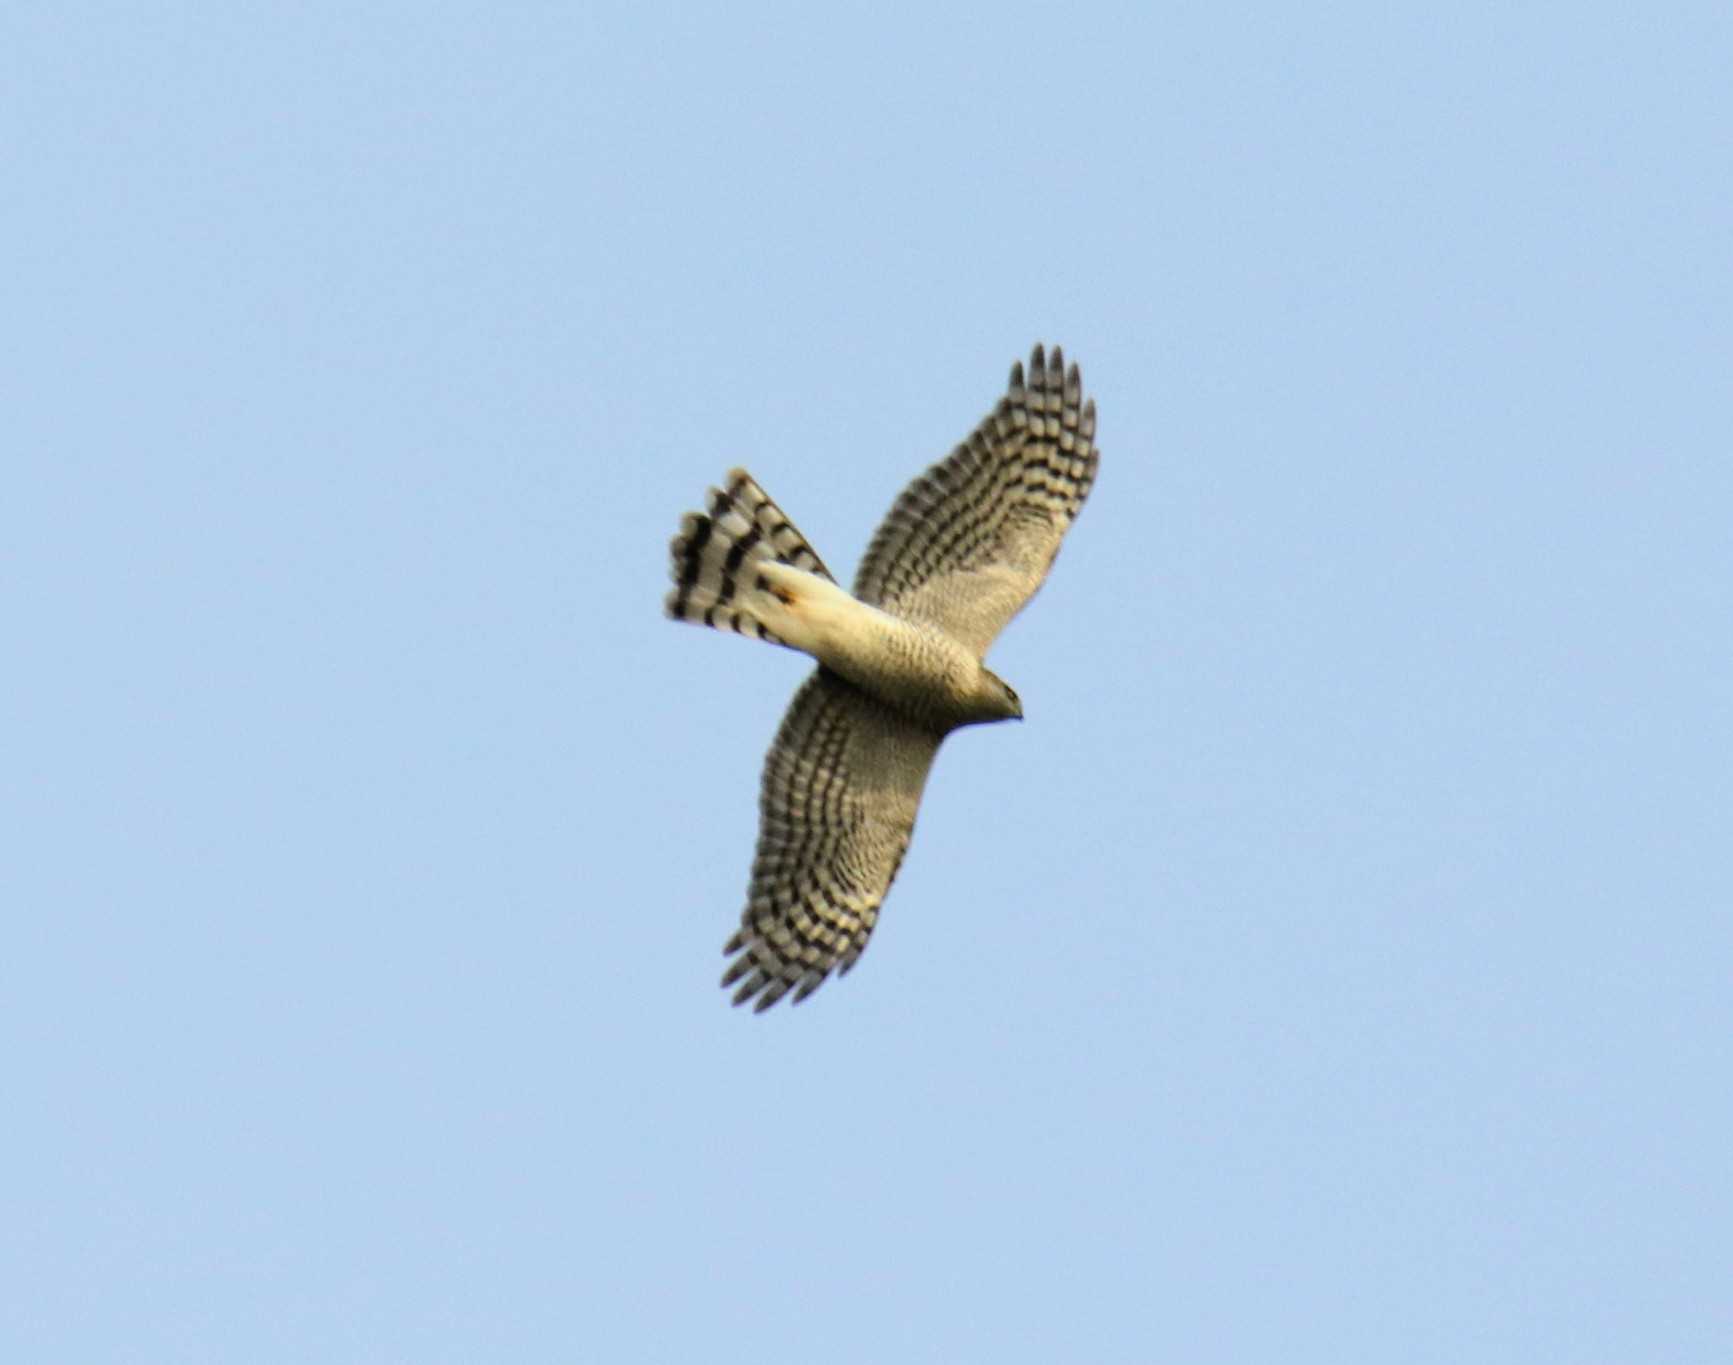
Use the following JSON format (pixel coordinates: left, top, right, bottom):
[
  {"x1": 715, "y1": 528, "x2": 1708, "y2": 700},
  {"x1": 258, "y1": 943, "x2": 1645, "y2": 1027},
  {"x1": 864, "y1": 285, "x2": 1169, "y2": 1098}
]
[{"x1": 854, "y1": 346, "x2": 1095, "y2": 653}]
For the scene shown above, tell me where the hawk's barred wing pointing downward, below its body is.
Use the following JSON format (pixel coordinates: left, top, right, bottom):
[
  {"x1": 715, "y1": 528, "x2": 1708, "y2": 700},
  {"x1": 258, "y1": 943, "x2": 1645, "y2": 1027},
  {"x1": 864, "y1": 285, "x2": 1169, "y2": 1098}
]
[{"x1": 723, "y1": 669, "x2": 939, "y2": 1010}]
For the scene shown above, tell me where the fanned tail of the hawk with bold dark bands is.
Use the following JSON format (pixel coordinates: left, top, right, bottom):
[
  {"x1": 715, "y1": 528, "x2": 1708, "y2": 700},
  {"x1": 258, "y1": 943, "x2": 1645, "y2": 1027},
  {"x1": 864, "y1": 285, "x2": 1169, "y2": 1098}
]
[{"x1": 667, "y1": 469, "x2": 835, "y2": 644}]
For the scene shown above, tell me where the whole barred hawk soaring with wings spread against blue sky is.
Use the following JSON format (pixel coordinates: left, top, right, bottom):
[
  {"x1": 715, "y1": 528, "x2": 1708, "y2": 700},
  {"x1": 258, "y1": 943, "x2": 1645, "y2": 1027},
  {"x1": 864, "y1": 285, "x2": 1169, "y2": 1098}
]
[{"x1": 667, "y1": 346, "x2": 1095, "y2": 1010}]
